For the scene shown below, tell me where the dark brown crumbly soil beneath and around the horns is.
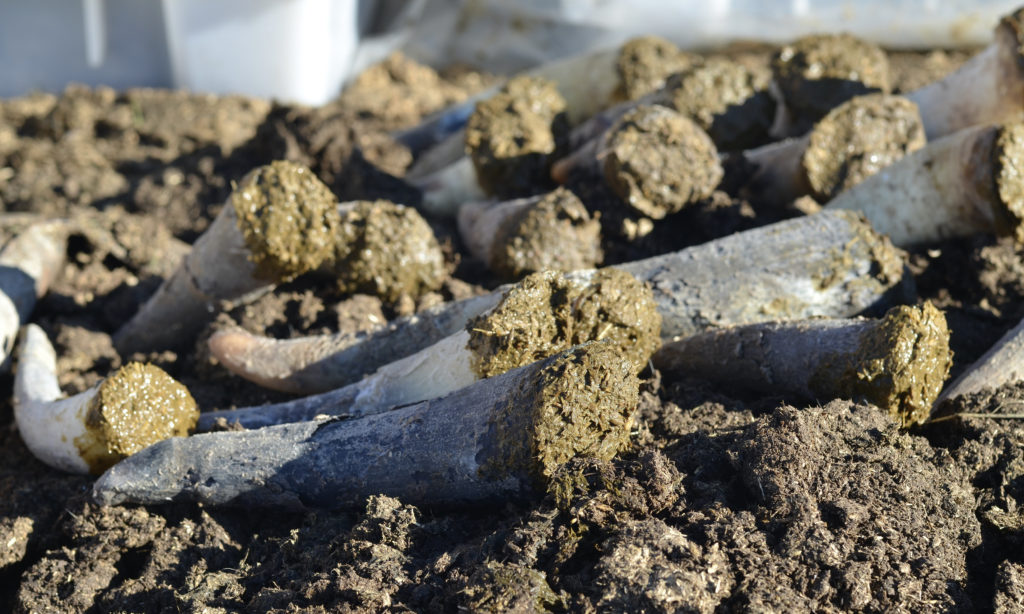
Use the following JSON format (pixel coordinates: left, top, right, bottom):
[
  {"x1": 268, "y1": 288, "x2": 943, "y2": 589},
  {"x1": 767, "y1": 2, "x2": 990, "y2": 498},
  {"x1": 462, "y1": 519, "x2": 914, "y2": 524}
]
[{"x1": 0, "y1": 44, "x2": 1024, "y2": 612}]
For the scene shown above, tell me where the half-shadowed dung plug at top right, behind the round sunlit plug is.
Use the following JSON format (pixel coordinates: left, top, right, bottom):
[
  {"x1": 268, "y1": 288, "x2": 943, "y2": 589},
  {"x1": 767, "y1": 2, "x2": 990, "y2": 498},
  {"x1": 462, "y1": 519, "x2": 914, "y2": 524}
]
[{"x1": 772, "y1": 34, "x2": 892, "y2": 133}]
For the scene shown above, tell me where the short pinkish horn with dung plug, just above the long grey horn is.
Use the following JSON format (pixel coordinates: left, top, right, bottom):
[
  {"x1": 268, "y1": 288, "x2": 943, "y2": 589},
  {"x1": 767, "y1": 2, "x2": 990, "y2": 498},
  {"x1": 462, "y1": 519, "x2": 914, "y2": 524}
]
[{"x1": 458, "y1": 187, "x2": 604, "y2": 281}]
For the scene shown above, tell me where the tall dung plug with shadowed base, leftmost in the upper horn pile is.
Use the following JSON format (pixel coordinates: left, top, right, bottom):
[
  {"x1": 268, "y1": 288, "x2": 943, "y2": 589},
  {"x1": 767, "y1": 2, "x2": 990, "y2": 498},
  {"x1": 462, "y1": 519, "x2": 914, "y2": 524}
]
[{"x1": 466, "y1": 77, "x2": 568, "y2": 199}]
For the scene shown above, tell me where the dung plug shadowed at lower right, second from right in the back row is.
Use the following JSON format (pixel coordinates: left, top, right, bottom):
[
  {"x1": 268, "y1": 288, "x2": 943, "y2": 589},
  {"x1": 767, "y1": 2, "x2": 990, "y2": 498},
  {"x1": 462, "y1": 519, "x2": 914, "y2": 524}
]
[{"x1": 658, "y1": 57, "x2": 775, "y2": 151}]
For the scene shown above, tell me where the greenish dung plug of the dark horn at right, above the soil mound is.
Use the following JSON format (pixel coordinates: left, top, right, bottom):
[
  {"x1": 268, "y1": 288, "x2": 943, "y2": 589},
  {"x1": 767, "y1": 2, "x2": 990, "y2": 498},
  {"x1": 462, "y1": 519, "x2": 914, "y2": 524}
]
[{"x1": 812, "y1": 303, "x2": 952, "y2": 428}]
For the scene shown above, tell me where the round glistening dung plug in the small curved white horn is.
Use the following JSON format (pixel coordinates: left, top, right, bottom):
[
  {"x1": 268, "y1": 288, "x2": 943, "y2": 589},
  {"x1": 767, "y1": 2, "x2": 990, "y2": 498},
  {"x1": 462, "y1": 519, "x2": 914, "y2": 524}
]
[{"x1": 75, "y1": 362, "x2": 199, "y2": 475}]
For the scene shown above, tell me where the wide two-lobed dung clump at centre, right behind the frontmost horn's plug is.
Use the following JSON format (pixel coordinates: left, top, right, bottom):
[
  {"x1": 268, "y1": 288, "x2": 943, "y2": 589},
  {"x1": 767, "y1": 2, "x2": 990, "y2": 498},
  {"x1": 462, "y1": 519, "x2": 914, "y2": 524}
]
[{"x1": 467, "y1": 268, "x2": 662, "y2": 378}]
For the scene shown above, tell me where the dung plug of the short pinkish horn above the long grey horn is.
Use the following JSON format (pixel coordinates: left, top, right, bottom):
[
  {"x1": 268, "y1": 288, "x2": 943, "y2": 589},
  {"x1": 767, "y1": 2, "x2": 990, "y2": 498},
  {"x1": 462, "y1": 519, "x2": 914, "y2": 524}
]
[{"x1": 489, "y1": 187, "x2": 603, "y2": 279}]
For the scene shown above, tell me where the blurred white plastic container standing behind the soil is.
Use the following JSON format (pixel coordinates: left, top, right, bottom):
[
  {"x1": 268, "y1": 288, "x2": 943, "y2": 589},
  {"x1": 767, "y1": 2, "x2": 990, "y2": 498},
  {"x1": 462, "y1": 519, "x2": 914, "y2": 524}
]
[{"x1": 156, "y1": 0, "x2": 358, "y2": 104}]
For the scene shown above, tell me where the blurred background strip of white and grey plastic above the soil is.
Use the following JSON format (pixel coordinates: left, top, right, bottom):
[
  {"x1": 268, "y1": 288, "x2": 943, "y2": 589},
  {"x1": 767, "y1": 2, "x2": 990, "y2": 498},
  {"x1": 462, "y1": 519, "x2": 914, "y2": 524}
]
[{"x1": 0, "y1": 0, "x2": 1019, "y2": 104}]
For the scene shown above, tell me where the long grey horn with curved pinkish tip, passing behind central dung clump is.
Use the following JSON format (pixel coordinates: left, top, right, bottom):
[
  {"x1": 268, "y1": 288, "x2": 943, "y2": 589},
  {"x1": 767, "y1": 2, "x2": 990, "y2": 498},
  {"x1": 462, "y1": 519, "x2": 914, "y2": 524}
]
[{"x1": 209, "y1": 212, "x2": 913, "y2": 394}]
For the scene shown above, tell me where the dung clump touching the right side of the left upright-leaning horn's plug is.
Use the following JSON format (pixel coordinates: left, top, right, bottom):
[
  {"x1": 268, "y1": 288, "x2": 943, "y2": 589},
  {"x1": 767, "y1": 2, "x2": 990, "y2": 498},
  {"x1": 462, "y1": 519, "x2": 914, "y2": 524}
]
[{"x1": 333, "y1": 201, "x2": 447, "y2": 303}]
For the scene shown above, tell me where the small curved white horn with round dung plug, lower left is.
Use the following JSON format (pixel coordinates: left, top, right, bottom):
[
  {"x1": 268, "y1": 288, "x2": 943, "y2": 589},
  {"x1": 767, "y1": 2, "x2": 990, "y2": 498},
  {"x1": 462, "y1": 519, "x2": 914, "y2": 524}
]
[{"x1": 14, "y1": 324, "x2": 199, "y2": 475}]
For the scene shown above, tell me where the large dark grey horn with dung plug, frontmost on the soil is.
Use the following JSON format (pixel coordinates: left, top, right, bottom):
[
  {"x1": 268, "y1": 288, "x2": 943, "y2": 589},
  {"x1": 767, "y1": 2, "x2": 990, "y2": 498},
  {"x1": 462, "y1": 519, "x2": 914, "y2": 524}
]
[{"x1": 92, "y1": 343, "x2": 639, "y2": 510}]
